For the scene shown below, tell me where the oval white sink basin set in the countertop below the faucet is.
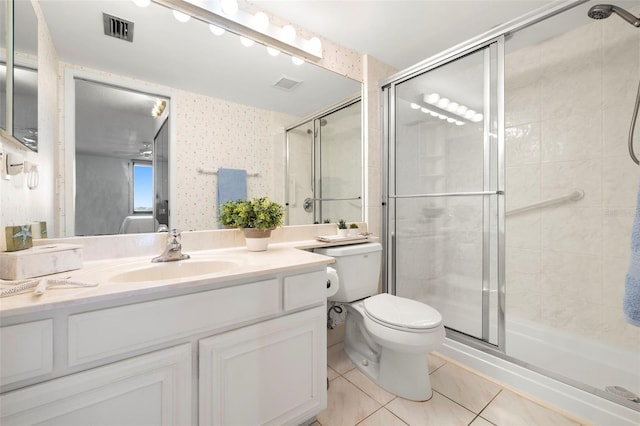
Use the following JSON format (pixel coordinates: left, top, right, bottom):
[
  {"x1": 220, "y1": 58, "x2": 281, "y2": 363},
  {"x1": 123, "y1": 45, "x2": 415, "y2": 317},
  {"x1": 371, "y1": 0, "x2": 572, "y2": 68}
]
[{"x1": 108, "y1": 260, "x2": 238, "y2": 283}]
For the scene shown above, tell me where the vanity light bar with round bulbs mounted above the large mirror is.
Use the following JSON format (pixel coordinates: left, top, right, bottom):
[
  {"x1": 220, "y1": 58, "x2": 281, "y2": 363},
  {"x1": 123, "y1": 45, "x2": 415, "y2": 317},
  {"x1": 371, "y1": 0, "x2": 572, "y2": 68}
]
[{"x1": 152, "y1": 0, "x2": 322, "y2": 63}]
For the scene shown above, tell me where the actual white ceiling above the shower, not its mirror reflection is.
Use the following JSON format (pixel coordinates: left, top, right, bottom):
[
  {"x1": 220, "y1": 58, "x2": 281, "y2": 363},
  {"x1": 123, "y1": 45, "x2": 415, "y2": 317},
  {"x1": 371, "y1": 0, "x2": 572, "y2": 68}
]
[{"x1": 250, "y1": 0, "x2": 552, "y2": 70}]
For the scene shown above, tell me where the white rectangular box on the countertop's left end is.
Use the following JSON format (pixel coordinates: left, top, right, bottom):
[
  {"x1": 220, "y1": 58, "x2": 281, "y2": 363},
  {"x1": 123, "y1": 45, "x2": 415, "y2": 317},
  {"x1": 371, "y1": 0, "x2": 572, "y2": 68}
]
[{"x1": 0, "y1": 244, "x2": 82, "y2": 280}]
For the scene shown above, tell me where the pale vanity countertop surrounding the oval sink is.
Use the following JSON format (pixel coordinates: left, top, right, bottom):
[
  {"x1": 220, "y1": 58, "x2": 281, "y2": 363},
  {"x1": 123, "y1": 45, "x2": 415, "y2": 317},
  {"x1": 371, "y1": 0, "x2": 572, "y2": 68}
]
[{"x1": 0, "y1": 240, "x2": 335, "y2": 318}]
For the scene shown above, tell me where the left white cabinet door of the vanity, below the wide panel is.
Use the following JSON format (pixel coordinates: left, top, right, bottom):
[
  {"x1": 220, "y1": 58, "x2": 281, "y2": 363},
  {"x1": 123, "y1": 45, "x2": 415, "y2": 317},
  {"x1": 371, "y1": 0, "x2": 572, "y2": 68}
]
[{"x1": 0, "y1": 344, "x2": 191, "y2": 426}]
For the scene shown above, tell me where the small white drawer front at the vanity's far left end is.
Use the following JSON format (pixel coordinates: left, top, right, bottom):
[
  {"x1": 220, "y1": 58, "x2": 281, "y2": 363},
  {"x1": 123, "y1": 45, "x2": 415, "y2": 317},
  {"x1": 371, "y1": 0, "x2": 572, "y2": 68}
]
[{"x1": 0, "y1": 319, "x2": 53, "y2": 385}]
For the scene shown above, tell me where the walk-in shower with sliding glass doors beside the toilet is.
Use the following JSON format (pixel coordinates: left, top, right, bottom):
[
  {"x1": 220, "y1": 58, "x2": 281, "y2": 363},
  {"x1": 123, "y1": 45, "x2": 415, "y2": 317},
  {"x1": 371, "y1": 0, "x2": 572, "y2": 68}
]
[{"x1": 383, "y1": 1, "x2": 640, "y2": 411}]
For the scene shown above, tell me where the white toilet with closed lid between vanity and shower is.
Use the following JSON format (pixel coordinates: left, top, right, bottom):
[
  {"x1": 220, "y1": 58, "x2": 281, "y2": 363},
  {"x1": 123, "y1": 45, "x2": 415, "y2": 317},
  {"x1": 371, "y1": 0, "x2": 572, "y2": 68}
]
[{"x1": 314, "y1": 243, "x2": 445, "y2": 401}]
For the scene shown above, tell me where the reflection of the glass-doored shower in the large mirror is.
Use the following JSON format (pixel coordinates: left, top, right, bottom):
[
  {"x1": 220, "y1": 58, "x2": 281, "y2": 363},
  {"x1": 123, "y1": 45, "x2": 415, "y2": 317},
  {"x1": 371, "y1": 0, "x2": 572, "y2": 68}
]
[{"x1": 285, "y1": 98, "x2": 363, "y2": 225}]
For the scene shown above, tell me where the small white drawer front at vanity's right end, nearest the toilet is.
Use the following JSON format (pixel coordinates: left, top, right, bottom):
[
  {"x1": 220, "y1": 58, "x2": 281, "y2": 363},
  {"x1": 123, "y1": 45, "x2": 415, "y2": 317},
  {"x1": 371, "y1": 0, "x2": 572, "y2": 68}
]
[{"x1": 284, "y1": 270, "x2": 327, "y2": 311}]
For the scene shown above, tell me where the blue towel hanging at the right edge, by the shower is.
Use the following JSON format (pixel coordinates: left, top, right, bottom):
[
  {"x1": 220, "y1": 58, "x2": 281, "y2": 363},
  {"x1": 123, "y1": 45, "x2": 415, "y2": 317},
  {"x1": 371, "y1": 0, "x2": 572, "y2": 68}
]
[{"x1": 622, "y1": 176, "x2": 640, "y2": 327}]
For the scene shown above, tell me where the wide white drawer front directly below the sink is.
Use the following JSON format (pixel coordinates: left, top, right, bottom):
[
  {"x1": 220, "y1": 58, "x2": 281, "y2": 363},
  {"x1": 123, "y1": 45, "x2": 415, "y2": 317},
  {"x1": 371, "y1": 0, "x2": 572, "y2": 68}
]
[{"x1": 69, "y1": 279, "x2": 281, "y2": 366}]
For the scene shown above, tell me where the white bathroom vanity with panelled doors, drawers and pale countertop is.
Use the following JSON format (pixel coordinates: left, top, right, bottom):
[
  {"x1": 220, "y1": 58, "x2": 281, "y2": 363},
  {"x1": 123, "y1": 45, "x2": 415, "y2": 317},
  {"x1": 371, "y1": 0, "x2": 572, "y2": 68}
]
[{"x1": 0, "y1": 246, "x2": 332, "y2": 426}]
